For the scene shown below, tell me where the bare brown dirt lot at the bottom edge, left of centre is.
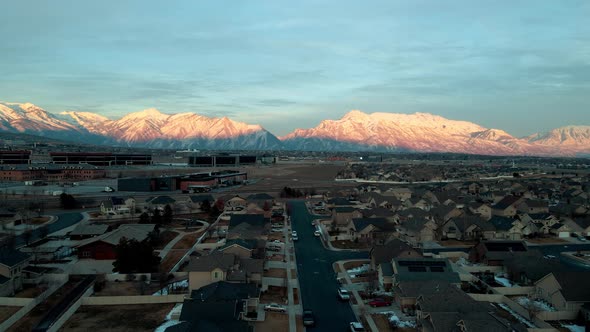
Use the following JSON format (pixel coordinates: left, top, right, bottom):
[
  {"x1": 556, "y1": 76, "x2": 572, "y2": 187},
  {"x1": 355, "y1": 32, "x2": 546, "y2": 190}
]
[{"x1": 62, "y1": 304, "x2": 174, "y2": 332}]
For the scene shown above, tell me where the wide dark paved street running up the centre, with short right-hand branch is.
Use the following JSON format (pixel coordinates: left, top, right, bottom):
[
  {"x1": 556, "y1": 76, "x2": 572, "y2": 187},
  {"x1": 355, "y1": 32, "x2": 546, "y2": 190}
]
[{"x1": 289, "y1": 201, "x2": 368, "y2": 331}]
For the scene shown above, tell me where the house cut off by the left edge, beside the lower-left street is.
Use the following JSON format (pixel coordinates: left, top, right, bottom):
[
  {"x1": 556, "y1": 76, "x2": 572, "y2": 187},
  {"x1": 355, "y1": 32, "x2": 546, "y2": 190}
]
[{"x1": 0, "y1": 248, "x2": 32, "y2": 296}]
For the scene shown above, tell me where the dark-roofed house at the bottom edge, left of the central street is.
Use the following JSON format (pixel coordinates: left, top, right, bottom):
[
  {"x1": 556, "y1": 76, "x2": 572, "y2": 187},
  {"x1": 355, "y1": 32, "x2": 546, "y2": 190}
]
[{"x1": 178, "y1": 281, "x2": 260, "y2": 332}]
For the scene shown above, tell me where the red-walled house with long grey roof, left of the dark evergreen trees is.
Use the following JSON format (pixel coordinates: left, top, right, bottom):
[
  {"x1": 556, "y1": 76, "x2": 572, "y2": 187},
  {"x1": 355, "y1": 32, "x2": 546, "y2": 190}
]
[{"x1": 75, "y1": 224, "x2": 156, "y2": 260}]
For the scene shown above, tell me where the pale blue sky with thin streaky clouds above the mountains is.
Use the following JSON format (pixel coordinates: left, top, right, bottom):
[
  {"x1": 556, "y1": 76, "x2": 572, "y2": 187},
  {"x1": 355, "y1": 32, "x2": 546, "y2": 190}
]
[{"x1": 0, "y1": 0, "x2": 590, "y2": 136}]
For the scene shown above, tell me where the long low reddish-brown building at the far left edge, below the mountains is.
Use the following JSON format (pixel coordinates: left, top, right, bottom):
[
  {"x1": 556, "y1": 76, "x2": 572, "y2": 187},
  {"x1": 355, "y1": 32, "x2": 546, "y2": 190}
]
[{"x1": 0, "y1": 164, "x2": 105, "y2": 182}]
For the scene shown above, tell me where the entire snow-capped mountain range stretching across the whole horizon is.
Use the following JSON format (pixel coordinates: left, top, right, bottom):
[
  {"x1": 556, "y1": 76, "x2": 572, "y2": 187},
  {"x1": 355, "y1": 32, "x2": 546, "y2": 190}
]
[{"x1": 0, "y1": 102, "x2": 590, "y2": 156}]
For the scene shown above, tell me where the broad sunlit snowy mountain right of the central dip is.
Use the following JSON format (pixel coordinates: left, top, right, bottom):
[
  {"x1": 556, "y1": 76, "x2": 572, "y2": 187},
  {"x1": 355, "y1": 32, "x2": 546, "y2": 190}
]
[{"x1": 281, "y1": 111, "x2": 590, "y2": 155}]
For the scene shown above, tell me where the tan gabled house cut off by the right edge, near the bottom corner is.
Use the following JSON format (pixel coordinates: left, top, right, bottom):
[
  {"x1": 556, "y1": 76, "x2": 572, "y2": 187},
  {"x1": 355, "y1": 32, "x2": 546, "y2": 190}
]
[{"x1": 535, "y1": 271, "x2": 590, "y2": 319}]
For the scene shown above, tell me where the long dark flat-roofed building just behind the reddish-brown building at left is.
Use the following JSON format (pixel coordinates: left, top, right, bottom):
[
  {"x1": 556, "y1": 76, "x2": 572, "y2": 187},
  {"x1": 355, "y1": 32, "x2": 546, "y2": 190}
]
[{"x1": 49, "y1": 152, "x2": 153, "y2": 166}]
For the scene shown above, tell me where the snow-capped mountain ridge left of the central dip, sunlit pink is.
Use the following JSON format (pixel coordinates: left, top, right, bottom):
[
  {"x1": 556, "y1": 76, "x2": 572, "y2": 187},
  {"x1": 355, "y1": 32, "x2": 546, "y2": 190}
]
[{"x1": 0, "y1": 103, "x2": 281, "y2": 150}]
